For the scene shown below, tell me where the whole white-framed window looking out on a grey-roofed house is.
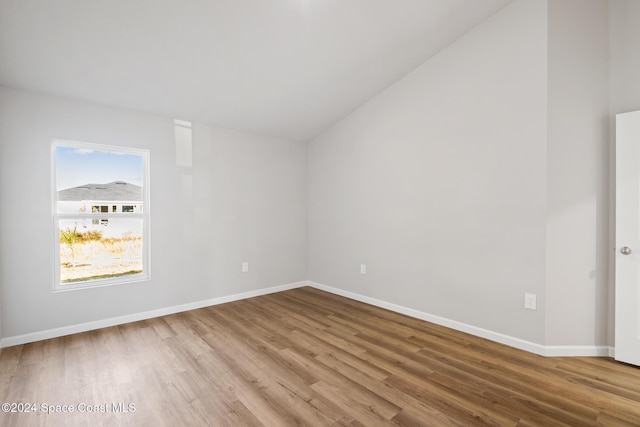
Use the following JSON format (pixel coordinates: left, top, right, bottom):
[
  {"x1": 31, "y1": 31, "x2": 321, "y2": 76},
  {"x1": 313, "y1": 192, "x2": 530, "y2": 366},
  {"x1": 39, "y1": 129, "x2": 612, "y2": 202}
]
[{"x1": 52, "y1": 140, "x2": 149, "y2": 290}]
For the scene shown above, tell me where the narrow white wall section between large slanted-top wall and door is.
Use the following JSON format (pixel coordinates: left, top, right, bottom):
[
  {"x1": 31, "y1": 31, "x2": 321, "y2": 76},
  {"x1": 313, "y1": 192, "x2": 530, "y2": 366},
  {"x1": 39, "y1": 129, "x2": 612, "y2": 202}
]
[{"x1": 546, "y1": 0, "x2": 609, "y2": 345}]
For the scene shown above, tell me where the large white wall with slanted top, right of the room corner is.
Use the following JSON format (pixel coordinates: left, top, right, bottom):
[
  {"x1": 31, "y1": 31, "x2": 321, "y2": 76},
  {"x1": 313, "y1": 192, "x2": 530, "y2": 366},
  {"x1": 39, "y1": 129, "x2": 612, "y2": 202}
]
[{"x1": 308, "y1": 0, "x2": 547, "y2": 343}]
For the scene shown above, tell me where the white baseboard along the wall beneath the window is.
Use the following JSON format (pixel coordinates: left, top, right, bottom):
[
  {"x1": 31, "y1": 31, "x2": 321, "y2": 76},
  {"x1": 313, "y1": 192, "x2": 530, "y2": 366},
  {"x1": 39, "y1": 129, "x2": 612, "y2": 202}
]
[{"x1": 0, "y1": 282, "x2": 308, "y2": 349}]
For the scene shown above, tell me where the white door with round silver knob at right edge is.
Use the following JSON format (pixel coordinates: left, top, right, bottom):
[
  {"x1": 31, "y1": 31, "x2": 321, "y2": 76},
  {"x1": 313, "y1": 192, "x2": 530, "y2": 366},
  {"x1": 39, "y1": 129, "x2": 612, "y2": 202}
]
[{"x1": 615, "y1": 111, "x2": 640, "y2": 366}]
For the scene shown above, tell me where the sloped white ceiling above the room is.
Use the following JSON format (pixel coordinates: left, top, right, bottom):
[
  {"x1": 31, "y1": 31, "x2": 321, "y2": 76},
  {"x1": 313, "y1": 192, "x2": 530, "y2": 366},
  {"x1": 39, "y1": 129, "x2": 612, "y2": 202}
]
[{"x1": 0, "y1": 0, "x2": 511, "y2": 141}]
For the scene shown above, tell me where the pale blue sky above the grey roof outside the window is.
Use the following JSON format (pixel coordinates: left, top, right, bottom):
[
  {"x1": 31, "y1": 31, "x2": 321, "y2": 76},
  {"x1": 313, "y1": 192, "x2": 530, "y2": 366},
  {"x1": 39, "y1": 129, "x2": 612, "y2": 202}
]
[{"x1": 55, "y1": 145, "x2": 144, "y2": 191}]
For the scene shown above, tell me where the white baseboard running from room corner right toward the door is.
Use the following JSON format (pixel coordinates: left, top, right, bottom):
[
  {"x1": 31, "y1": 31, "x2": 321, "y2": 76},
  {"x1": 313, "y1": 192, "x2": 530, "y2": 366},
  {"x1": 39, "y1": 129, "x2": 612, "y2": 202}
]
[{"x1": 308, "y1": 281, "x2": 613, "y2": 357}]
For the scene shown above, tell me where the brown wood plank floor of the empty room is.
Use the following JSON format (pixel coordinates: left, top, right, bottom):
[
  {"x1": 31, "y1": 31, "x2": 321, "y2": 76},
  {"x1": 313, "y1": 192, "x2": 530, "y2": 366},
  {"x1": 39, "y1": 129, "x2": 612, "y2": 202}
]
[{"x1": 0, "y1": 288, "x2": 640, "y2": 427}]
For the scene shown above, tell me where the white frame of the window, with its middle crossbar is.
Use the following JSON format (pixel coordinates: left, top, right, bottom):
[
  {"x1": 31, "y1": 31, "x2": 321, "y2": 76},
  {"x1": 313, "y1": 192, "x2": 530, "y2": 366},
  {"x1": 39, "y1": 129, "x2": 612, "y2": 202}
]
[{"x1": 51, "y1": 139, "x2": 151, "y2": 292}]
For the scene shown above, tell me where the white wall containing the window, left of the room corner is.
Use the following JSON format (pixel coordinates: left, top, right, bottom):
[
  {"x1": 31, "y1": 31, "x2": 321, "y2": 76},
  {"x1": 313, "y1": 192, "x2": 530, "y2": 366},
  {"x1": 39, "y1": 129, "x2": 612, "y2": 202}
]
[{"x1": 0, "y1": 88, "x2": 306, "y2": 338}]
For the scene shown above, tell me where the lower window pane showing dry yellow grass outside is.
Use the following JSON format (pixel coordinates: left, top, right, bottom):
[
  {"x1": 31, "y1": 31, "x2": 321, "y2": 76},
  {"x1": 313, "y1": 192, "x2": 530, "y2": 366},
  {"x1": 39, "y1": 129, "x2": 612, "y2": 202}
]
[{"x1": 58, "y1": 216, "x2": 143, "y2": 283}]
